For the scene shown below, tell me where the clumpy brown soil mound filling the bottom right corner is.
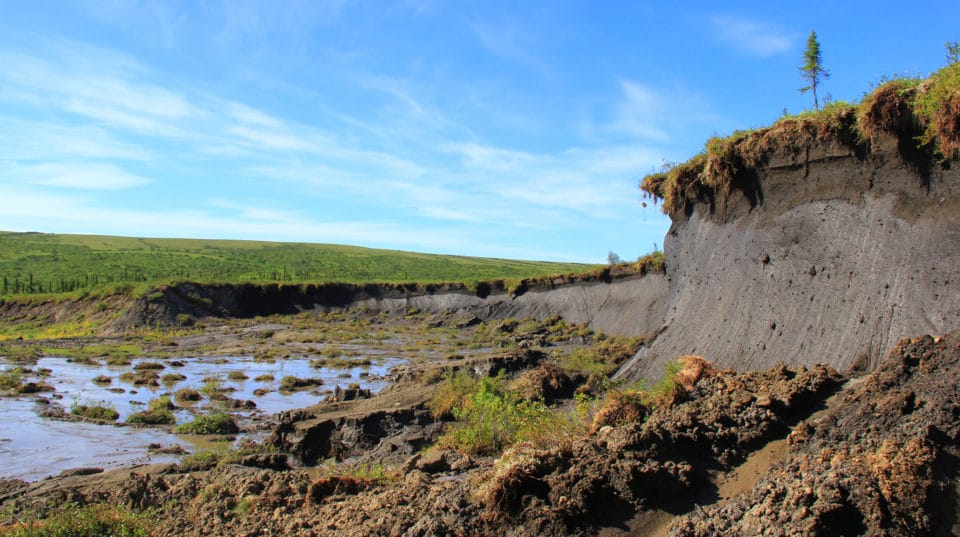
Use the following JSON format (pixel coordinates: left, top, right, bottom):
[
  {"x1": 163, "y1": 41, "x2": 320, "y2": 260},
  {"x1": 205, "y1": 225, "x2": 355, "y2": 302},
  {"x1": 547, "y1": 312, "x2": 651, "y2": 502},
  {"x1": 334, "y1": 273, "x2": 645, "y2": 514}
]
[{"x1": 671, "y1": 332, "x2": 960, "y2": 537}]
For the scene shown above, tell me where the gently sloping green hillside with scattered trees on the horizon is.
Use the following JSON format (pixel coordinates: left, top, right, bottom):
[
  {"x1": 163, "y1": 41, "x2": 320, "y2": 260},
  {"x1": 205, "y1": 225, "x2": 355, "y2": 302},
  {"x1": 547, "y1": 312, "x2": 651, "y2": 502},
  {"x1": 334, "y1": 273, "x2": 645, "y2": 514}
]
[{"x1": 0, "y1": 232, "x2": 594, "y2": 295}]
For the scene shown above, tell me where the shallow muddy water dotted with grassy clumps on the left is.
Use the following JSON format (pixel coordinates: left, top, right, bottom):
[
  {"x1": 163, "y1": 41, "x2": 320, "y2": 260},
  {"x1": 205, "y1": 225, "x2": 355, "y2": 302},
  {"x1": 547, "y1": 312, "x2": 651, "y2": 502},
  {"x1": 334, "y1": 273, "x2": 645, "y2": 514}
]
[{"x1": 0, "y1": 355, "x2": 403, "y2": 480}]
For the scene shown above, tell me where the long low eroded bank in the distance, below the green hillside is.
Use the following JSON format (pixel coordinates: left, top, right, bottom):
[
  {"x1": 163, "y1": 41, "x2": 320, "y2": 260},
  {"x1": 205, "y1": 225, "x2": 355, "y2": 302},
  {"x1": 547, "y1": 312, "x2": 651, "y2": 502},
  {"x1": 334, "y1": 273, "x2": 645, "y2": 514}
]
[{"x1": 117, "y1": 266, "x2": 667, "y2": 336}]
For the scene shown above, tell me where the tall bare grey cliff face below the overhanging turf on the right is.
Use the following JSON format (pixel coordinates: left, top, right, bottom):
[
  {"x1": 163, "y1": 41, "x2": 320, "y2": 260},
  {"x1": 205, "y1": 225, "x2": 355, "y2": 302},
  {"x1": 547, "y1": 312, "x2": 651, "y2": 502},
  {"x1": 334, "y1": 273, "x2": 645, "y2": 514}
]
[{"x1": 619, "y1": 133, "x2": 960, "y2": 378}]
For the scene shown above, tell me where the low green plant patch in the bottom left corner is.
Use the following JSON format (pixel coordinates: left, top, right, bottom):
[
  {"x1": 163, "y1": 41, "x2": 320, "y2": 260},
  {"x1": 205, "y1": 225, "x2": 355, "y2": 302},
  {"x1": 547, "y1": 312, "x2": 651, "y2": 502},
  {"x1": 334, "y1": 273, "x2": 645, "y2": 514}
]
[{"x1": 0, "y1": 504, "x2": 155, "y2": 537}]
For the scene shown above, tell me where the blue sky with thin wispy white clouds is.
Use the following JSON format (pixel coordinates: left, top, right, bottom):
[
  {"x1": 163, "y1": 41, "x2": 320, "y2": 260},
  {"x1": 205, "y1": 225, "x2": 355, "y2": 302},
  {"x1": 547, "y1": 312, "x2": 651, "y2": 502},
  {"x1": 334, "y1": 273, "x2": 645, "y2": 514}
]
[{"x1": 0, "y1": 0, "x2": 960, "y2": 262}]
